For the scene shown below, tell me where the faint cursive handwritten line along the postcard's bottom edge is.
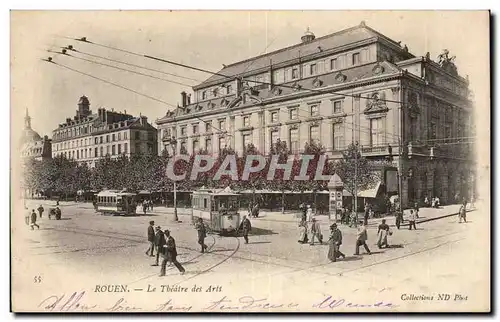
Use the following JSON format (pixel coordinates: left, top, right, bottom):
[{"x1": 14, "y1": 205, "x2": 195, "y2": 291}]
[{"x1": 38, "y1": 291, "x2": 397, "y2": 312}]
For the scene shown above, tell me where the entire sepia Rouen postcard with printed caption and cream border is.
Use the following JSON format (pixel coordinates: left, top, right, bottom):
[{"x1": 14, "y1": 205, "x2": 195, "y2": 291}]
[{"x1": 10, "y1": 10, "x2": 491, "y2": 313}]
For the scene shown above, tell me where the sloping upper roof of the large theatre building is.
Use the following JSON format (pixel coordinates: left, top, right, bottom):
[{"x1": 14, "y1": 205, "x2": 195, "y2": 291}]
[{"x1": 193, "y1": 22, "x2": 400, "y2": 90}]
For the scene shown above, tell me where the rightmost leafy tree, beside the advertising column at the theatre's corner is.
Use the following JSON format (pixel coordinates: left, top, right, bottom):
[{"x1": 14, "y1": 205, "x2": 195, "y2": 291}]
[{"x1": 334, "y1": 144, "x2": 377, "y2": 206}]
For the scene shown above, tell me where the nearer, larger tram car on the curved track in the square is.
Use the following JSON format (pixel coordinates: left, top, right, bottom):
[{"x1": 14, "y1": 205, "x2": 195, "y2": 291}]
[{"x1": 192, "y1": 187, "x2": 241, "y2": 236}]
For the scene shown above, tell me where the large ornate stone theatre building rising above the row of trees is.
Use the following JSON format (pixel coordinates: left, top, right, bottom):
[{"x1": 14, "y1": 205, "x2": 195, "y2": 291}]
[{"x1": 157, "y1": 22, "x2": 473, "y2": 205}]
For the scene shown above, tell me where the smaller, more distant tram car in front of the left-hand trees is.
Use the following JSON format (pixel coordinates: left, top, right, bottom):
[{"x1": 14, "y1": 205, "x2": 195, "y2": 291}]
[{"x1": 95, "y1": 190, "x2": 137, "y2": 216}]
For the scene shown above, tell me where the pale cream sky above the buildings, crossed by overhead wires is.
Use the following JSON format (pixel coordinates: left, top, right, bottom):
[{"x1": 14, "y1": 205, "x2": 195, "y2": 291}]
[{"x1": 11, "y1": 11, "x2": 490, "y2": 140}]
